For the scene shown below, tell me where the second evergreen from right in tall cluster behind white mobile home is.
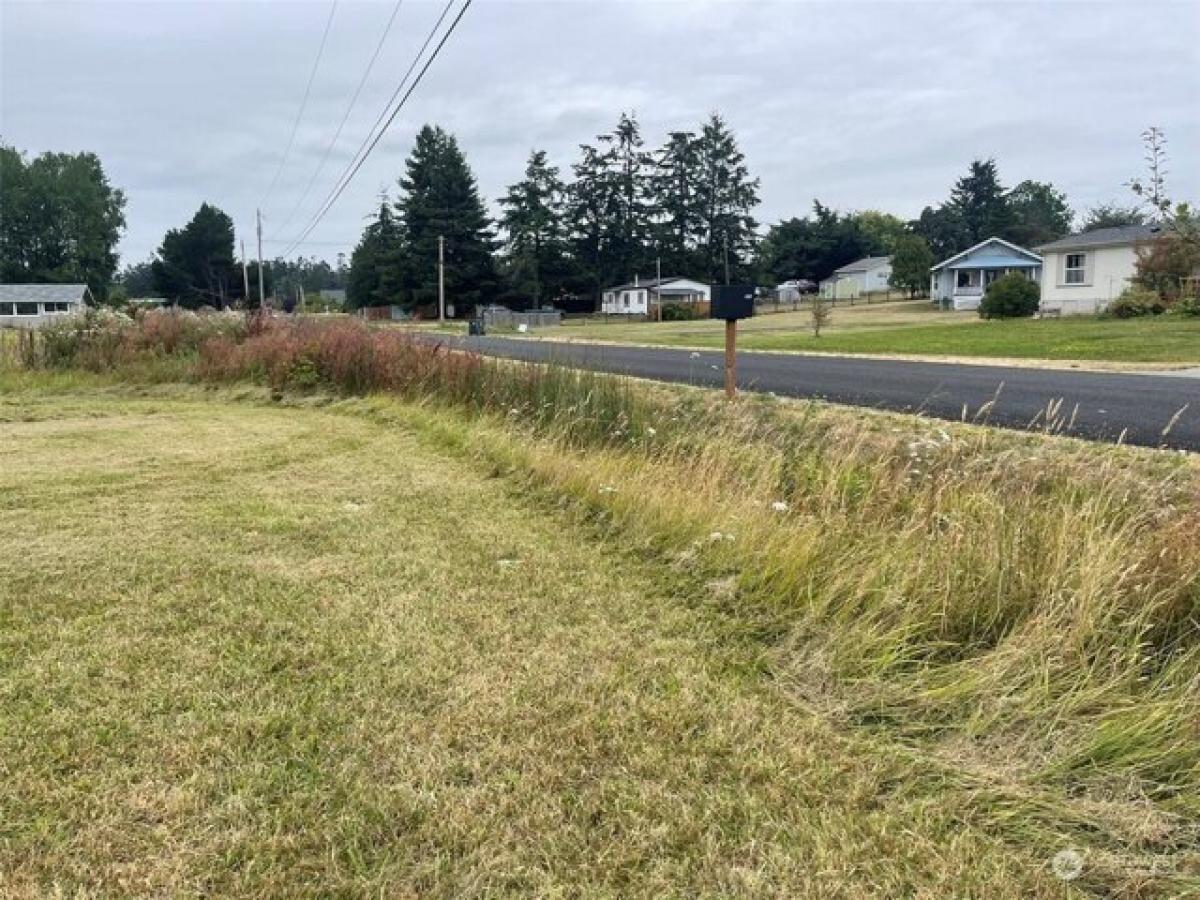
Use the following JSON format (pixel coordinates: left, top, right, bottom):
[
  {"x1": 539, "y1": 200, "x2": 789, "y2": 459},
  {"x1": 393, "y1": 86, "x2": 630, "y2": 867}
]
[{"x1": 650, "y1": 131, "x2": 703, "y2": 275}]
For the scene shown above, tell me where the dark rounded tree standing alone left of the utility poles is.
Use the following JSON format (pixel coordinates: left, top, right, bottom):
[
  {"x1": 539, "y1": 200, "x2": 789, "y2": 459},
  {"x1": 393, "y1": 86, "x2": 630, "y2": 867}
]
[{"x1": 151, "y1": 203, "x2": 241, "y2": 308}]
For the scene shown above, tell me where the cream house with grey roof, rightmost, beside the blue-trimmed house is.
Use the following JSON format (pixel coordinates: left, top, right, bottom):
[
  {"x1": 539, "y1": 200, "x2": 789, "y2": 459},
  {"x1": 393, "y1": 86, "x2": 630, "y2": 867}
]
[{"x1": 1038, "y1": 226, "x2": 1158, "y2": 316}]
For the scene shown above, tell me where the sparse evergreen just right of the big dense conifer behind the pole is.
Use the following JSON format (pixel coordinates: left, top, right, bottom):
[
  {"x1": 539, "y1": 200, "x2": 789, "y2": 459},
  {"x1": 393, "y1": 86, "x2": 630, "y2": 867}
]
[{"x1": 500, "y1": 150, "x2": 566, "y2": 307}]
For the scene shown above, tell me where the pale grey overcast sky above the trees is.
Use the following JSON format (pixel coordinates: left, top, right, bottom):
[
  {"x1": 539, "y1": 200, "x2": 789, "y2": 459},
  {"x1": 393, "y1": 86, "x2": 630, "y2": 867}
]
[{"x1": 0, "y1": 0, "x2": 1200, "y2": 263}]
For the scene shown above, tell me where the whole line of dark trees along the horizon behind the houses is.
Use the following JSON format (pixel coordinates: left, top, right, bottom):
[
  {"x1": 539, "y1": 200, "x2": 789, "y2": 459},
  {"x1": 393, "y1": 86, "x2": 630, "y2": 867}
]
[{"x1": 0, "y1": 127, "x2": 1176, "y2": 312}]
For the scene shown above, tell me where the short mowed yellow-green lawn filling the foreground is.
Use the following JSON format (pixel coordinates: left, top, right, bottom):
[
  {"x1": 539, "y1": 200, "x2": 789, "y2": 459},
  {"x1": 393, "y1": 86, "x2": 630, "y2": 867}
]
[{"x1": 0, "y1": 384, "x2": 1070, "y2": 898}]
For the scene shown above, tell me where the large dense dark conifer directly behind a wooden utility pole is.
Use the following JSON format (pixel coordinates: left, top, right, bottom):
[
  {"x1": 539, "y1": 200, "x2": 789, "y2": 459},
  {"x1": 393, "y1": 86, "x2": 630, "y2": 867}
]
[{"x1": 396, "y1": 125, "x2": 498, "y2": 311}]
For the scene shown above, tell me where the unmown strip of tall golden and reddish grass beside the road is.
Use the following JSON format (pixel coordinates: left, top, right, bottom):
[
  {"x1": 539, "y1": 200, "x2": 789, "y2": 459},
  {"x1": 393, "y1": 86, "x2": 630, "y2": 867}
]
[{"x1": 18, "y1": 317, "x2": 1200, "y2": 868}]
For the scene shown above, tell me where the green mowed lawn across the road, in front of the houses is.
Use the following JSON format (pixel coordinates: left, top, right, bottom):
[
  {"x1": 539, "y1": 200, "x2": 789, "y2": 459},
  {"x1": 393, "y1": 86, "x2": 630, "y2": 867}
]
[{"x1": 539, "y1": 300, "x2": 1200, "y2": 364}]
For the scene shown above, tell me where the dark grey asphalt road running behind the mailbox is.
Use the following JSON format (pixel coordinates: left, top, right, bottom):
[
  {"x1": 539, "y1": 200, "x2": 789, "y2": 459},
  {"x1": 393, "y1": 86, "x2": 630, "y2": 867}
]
[{"x1": 442, "y1": 337, "x2": 1200, "y2": 451}]
